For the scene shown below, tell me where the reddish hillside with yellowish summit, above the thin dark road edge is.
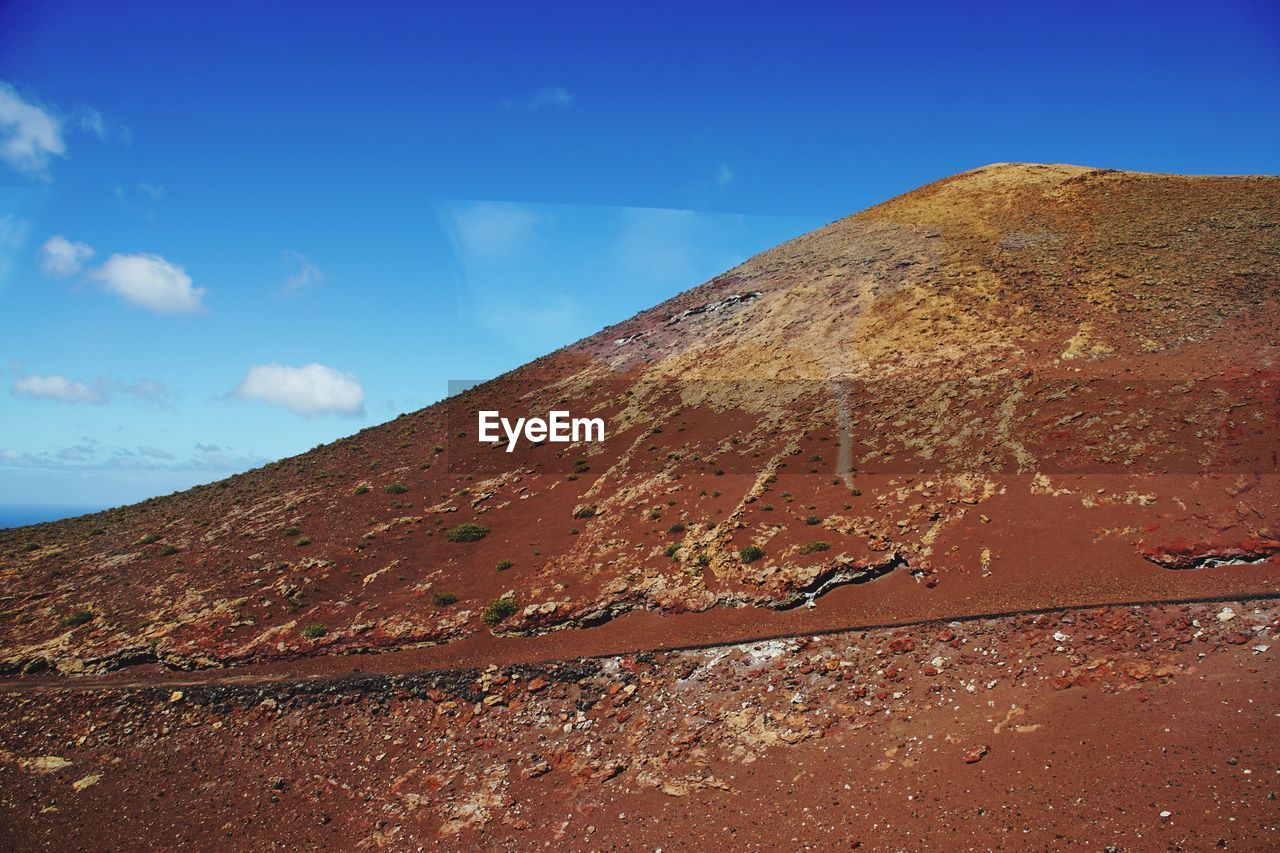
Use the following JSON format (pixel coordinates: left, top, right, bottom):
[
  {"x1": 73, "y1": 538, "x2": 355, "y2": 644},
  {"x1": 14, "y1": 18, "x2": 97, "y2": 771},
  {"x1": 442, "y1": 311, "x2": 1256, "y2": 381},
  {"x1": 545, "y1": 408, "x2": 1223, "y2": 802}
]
[{"x1": 0, "y1": 165, "x2": 1280, "y2": 675}]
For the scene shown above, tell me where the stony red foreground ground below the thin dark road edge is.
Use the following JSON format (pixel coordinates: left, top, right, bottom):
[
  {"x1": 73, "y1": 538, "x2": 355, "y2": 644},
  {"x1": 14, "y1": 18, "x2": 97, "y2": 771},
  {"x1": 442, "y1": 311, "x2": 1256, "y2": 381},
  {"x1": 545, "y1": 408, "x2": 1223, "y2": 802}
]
[{"x1": 0, "y1": 602, "x2": 1280, "y2": 850}]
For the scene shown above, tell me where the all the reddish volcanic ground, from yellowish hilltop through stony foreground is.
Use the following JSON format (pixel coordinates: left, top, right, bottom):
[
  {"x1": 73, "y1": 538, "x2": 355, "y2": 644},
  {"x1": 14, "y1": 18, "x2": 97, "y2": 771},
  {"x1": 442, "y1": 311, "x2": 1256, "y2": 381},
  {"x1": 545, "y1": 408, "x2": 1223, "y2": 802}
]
[{"x1": 0, "y1": 165, "x2": 1280, "y2": 849}]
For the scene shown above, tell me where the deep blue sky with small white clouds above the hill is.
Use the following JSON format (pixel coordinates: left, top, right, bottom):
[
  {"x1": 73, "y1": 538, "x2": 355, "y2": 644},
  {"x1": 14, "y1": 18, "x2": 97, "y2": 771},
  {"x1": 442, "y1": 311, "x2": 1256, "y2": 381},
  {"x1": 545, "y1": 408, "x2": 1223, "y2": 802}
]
[{"x1": 0, "y1": 0, "x2": 1280, "y2": 506}]
